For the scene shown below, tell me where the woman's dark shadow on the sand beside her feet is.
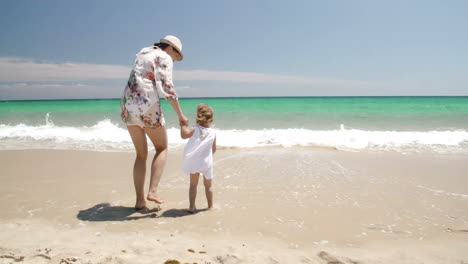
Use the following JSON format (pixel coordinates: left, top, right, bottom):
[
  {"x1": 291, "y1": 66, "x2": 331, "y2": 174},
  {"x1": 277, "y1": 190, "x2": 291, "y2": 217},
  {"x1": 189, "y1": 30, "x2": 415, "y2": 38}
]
[{"x1": 76, "y1": 203, "x2": 160, "y2": 222}]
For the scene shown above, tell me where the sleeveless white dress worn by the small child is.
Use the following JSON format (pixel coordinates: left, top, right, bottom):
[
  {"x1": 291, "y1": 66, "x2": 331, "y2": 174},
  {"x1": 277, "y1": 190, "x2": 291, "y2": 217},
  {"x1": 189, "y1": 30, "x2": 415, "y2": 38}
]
[{"x1": 182, "y1": 124, "x2": 216, "y2": 179}]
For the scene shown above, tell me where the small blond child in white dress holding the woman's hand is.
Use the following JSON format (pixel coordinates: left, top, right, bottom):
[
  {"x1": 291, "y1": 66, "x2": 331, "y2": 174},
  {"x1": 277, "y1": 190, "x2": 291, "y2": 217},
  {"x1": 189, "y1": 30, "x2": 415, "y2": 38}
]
[{"x1": 180, "y1": 104, "x2": 216, "y2": 213}]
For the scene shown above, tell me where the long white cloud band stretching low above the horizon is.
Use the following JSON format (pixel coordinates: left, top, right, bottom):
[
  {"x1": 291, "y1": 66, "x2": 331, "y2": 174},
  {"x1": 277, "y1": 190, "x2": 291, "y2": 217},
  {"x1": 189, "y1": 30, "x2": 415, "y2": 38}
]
[{"x1": 0, "y1": 57, "x2": 371, "y2": 86}]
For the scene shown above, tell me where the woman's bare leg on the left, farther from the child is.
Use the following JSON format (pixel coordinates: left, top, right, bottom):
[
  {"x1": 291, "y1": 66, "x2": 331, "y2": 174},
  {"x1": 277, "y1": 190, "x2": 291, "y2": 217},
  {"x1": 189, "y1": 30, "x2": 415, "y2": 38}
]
[{"x1": 127, "y1": 126, "x2": 148, "y2": 209}]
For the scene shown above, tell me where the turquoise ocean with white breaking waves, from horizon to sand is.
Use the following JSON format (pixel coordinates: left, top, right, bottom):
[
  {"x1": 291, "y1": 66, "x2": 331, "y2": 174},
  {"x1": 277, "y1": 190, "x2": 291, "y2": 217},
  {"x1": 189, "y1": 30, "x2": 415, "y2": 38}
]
[{"x1": 0, "y1": 97, "x2": 468, "y2": 155}]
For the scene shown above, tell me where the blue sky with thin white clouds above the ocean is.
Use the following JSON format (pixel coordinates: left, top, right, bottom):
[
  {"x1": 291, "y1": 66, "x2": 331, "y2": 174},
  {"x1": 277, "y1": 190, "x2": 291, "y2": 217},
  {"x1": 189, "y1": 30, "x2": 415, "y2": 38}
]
[{"x1": 0, "y1": 0, "x2": 468, "y2": 100}]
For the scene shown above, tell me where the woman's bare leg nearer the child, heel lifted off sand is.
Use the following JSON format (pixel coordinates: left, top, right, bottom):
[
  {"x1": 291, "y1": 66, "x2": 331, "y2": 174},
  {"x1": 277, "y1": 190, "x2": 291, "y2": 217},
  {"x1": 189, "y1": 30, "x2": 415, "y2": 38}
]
[{"x1": 145, "y1": 126, "x2": 167, "y2": 203}]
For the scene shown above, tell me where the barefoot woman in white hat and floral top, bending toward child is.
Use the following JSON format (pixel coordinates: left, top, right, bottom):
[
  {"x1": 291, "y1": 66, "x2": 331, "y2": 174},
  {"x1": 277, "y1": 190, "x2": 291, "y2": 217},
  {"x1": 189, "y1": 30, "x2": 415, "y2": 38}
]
[{"x1": 120, "y1": 35, "x2": 188, "y2": 209}]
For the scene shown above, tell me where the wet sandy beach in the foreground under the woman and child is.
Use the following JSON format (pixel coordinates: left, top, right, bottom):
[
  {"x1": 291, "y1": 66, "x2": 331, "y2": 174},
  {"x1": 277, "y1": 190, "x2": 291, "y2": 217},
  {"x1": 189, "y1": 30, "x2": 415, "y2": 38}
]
[{"x1": 0, "y1": 147, "x2": 468, "y2": 264}]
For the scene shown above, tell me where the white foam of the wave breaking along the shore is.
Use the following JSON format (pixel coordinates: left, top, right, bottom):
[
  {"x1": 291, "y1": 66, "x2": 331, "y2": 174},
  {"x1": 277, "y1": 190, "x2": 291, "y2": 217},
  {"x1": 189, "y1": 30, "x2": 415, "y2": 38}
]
[{"x1": 0, "y1": 118, "x2": 468, "y2": 154}]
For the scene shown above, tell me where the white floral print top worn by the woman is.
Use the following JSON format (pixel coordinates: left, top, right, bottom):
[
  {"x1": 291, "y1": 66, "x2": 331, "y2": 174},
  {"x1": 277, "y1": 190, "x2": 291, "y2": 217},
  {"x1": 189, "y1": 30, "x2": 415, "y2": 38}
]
[{"x1": 120, "y1": 47, "x2": 177, "y2": 128}]
